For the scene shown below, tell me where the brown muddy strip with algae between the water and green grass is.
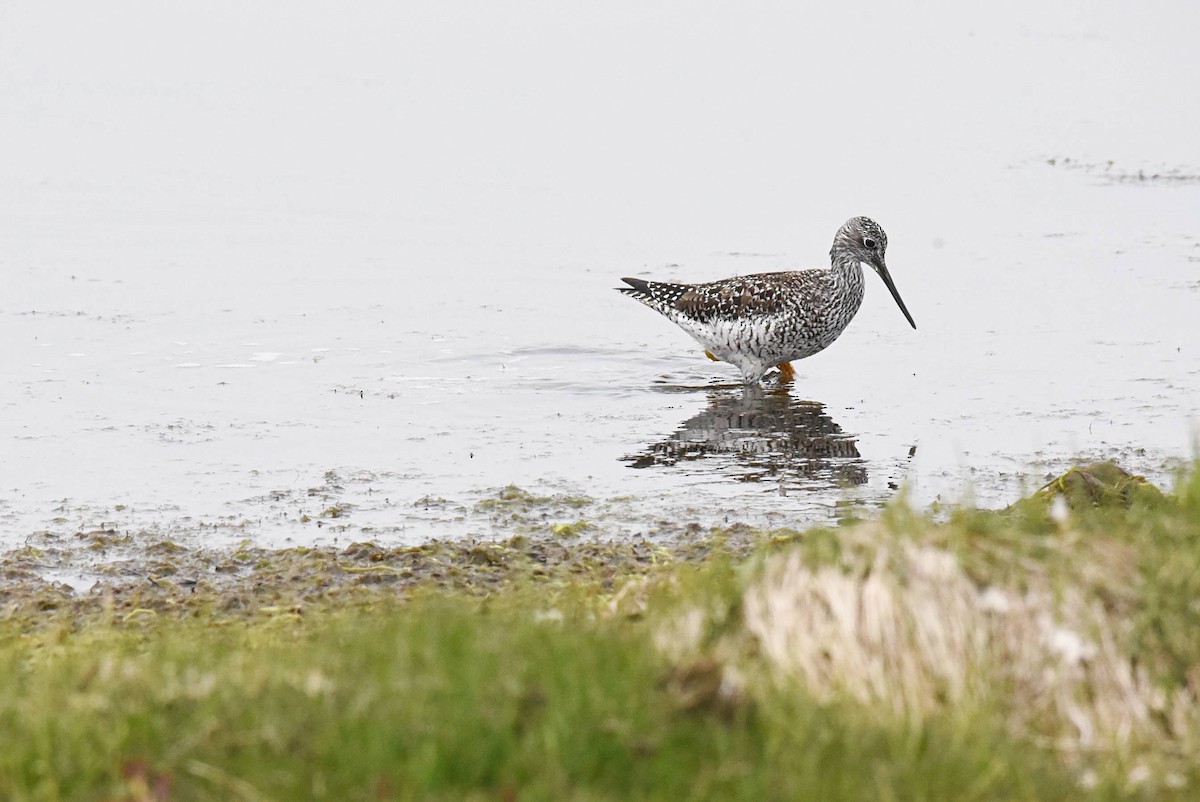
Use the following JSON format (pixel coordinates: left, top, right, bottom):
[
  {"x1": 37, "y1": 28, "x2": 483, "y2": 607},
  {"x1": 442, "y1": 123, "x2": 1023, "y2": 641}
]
[{"x1": 0, "y1": 525, "x2": 763, "y2": 623}]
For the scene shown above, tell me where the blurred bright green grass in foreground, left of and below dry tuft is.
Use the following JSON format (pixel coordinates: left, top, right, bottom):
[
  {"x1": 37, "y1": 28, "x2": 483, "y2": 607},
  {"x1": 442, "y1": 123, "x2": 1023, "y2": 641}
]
[{"x1": 0, "y1": 595, "x2": 1072, "y2": 800}]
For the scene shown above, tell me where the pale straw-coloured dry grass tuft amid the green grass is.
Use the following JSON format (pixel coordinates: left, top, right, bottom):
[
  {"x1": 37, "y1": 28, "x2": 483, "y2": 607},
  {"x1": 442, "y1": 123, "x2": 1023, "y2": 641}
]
[{"x1": 743, "y1": 525, "x2": 1200, "y2": 761}]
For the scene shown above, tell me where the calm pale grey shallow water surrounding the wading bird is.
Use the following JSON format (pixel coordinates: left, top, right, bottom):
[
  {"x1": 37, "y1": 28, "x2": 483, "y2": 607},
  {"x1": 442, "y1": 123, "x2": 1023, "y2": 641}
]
[{"x1": 0, "y1": 4, "x2": 1200, "y2": 564}]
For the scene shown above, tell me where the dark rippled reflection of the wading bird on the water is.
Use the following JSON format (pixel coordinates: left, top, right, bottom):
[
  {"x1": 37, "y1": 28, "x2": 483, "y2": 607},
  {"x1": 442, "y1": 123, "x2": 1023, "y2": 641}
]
[{"x1": 622, "y1": 387, "x2": 866, "y2": 490}]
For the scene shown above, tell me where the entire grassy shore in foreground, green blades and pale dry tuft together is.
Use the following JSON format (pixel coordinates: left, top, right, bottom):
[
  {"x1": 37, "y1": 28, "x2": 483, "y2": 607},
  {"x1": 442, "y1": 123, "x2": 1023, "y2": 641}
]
[{"x1": 0, "y1": 466, "x2": 1200, "y2": 800}]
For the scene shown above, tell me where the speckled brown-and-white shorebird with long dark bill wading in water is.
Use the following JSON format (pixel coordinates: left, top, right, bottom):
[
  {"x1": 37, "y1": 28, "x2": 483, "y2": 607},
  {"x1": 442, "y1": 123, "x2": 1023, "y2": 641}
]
[{"x1": 618, "y1": 217, "x2": 917, "y2": 384}]
